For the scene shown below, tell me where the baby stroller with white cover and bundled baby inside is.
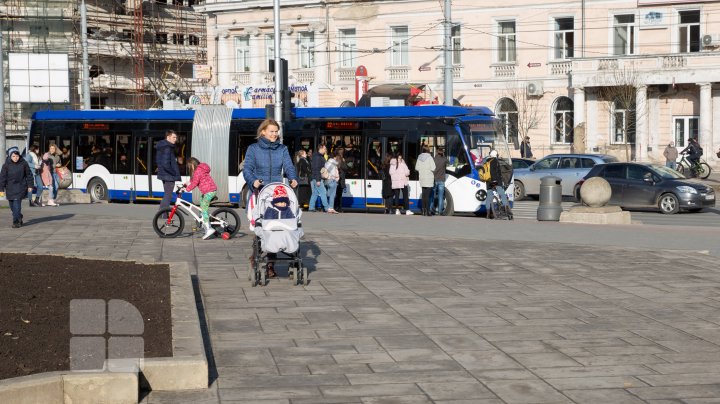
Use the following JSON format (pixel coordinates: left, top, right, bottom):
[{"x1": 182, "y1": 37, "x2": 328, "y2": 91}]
[{"x1": 248, "y1": 182, "x2": 308, "y2": 286}]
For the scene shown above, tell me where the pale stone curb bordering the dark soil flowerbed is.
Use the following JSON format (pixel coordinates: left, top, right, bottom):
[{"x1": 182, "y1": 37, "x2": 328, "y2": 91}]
[{"x1": 0, "y1": 258, "x2": 208, "y2": 404}]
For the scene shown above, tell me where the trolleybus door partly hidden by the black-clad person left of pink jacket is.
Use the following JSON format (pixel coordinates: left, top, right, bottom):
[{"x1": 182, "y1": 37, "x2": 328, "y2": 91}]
[{"x1": 363, "y1": 135, "x2": 404, "y2": 210}]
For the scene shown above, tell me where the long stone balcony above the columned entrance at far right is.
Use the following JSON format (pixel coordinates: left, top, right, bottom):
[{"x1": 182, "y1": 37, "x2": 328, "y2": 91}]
[{"x1": 570, "y1": 52, "x2": 720, "y2": 87}]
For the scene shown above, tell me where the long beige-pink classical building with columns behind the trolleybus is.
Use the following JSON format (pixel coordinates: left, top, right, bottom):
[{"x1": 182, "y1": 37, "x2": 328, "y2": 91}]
[{"x1": 195, "y1": 0, "x2": 720, "y2": 163}]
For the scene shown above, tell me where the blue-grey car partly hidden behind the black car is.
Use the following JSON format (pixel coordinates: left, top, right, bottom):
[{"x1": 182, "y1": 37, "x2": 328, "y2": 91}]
[{"x1": 514, "y1": 154, "x2": 618, "y2": 201}]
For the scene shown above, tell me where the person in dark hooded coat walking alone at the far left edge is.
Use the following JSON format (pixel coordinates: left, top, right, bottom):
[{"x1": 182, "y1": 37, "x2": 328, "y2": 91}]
[{"x1": 0, "y1": 147, "x2": 33, "y2": 229}]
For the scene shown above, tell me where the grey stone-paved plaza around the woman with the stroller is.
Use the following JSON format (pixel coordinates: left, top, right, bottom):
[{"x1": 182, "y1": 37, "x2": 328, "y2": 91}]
[{"x1": 0, "y1": 204, "x2": 720, "y2": 404}]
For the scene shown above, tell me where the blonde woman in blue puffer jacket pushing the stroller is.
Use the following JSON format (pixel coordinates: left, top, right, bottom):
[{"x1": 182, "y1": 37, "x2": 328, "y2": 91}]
[{"x1": 243, "y1": 119, "x2": 298, "y2": 278}]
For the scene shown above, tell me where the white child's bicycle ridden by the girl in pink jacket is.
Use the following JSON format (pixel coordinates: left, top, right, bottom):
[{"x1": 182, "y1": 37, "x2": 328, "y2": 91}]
[{"x1": 153, "y1": 185, "x2": 240, "y2": 240}]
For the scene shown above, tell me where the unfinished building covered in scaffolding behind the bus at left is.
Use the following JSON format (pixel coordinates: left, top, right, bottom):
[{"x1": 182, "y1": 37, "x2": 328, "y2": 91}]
[{"x1": 0, "y1": 0, "x2": 207, "y2": 133}]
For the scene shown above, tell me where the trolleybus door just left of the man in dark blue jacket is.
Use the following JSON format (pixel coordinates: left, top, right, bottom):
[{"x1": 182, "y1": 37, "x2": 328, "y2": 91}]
[{"x1": 133, "y1": 132, "x2": 165, "y2": 199}]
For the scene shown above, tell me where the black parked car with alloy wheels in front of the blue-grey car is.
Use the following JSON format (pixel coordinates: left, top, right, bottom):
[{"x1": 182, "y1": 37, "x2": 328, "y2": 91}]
[{"x1": 577, "y1": 163, "x2": 715, "y2": 214}]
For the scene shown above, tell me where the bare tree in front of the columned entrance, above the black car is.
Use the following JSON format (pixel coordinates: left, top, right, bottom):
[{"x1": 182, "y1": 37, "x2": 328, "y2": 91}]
[{"x1": 598, "y1": 65, "x2": 646, "y2": 161}]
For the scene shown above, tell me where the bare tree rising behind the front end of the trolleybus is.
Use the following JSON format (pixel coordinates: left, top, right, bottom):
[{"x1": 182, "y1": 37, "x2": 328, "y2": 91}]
[{"x1": 499, "y1": 80, "x2": 541, "y2": 149}]
